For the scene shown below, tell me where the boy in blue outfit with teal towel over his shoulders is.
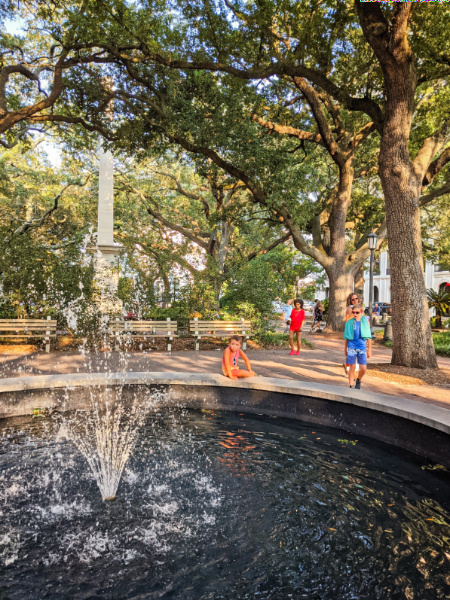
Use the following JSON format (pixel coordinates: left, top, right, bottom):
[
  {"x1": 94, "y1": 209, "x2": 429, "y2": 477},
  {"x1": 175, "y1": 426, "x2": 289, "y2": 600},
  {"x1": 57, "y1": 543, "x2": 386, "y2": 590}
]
[{"x1": 344, "y1": 304, "x2": 372, "y2": 390}]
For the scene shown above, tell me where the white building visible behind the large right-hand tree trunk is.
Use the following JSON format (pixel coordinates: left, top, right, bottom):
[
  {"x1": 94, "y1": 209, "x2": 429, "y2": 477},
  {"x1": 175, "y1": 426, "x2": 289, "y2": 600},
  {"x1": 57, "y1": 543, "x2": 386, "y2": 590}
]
[{"x1": 364, "y1": 252, "x2": 450, "y2": 304}]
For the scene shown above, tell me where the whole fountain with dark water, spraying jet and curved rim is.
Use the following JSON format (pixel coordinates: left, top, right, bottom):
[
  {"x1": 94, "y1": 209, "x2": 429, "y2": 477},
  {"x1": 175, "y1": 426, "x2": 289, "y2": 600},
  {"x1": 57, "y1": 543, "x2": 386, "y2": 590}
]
[{"x1": 0, "y1": 373, "x2": 450, "y2": 600}]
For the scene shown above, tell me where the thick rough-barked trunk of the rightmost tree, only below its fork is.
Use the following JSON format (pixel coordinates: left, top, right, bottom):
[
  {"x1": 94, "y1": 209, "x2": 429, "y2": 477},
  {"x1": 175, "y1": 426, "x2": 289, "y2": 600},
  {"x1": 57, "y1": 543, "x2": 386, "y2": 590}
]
[{"x1": 379, "y1": 70, "x2": 437, "y2": 369}]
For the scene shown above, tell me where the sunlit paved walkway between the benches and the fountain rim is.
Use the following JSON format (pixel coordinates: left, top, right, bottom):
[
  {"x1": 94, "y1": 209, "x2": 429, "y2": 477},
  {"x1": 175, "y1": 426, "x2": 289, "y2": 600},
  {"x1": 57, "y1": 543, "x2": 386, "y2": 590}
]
[{"x1": 0, "y1": 336, "x2": 450, "y2": 408}]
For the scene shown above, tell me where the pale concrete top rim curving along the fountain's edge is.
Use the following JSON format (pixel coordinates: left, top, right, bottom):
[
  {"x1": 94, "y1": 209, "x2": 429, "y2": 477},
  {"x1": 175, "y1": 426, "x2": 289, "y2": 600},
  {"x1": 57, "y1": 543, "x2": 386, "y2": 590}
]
[{"x1": 0, "y1": 371, "x2": 450, "y2": 435}]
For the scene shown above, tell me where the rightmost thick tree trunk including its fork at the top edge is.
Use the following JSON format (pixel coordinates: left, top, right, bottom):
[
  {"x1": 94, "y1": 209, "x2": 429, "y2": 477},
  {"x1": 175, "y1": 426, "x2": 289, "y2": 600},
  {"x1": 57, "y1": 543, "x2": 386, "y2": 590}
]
[{"x1": 356, "y1": 0, "x2": 437, "y2": 369}]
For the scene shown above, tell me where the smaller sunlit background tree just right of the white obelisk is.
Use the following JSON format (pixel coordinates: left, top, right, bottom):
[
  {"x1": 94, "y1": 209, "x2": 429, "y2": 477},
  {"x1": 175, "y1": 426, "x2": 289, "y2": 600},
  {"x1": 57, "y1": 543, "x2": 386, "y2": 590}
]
[{"x1": 112, "y1": 159, "x2": 290, "y2": 310}]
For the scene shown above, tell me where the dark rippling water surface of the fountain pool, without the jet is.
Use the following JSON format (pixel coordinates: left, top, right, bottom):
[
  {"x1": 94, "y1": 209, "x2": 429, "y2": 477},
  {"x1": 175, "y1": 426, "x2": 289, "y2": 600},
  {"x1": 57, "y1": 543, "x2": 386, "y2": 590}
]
[{"x1": 0, "y1": 410, "x2": 450, "y2": 600}]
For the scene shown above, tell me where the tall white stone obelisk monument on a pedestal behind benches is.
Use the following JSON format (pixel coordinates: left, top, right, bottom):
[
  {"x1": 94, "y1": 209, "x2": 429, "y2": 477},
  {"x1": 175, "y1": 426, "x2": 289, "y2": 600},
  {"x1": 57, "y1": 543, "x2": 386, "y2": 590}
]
[{"x1": 93, "y1": 147, "x2": 122, "y2": 313}]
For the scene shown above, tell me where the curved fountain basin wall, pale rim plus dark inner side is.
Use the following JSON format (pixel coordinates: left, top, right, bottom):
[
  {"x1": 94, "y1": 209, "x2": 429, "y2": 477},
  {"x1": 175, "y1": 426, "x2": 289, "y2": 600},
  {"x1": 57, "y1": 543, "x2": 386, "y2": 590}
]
[{"x1": 0, "y1": 372, "x2": 450, "y2": 468}]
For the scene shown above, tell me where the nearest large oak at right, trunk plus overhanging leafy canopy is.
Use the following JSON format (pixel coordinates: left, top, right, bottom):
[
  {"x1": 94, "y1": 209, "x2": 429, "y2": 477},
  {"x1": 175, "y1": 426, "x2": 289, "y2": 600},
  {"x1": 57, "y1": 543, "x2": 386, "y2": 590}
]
[{"x1": 100, "y1": 0, "x2": 450, "y2": 368}]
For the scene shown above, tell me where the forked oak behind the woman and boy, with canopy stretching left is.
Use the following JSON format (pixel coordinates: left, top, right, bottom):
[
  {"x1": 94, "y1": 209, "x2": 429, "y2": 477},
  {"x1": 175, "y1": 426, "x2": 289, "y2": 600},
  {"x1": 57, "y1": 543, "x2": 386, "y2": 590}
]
[{"x1": 43, "y1": 27, "x2": 385, "y2": 329}]
